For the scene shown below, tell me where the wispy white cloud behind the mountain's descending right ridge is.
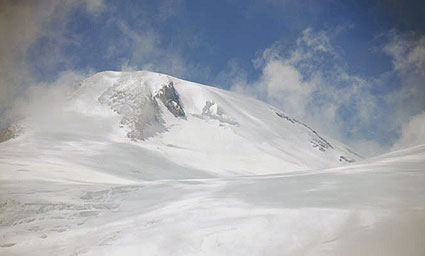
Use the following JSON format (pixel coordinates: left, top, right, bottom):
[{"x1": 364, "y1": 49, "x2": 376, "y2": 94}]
[{"x1": 232, "y1": 28, "x2": 425, "y2": 156}]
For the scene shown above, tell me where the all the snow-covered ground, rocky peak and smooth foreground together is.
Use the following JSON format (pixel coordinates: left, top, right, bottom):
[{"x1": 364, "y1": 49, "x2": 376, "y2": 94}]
[{"x1": 0, "y1": 71, "x2": 425, "y2": 255}]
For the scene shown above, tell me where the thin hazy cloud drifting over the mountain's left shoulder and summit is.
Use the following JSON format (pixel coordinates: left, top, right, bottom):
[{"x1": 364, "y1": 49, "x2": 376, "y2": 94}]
[{"x1": 0, "y1": 0, "x2": 195, "y2": 128}]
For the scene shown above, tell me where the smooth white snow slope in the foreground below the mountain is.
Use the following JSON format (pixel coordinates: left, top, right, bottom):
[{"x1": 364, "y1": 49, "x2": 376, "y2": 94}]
[{"x1": 0, "y1": 141, "x2": 425, "y2": 256}]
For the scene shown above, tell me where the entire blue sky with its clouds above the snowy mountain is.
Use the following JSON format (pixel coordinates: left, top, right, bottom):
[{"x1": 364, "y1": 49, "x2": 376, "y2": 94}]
[{"x1": 0, "y1": 0, "x2": 425, "y2": 155}]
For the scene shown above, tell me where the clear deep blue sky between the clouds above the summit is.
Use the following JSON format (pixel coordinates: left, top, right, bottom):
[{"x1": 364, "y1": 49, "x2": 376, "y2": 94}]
[{"x1": 24, "y1": 1, "x2": 402, "y2": 79}]
